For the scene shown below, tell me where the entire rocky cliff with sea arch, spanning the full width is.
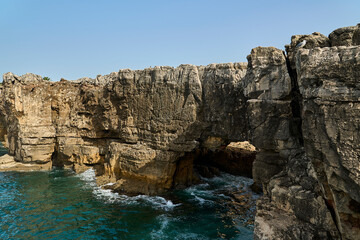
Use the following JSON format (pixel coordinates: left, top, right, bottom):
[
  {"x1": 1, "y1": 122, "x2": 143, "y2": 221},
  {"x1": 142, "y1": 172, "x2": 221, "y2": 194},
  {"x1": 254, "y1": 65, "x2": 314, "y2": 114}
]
[{"x1": 0, "y1": 23, "x2": 360, "y2": 239}]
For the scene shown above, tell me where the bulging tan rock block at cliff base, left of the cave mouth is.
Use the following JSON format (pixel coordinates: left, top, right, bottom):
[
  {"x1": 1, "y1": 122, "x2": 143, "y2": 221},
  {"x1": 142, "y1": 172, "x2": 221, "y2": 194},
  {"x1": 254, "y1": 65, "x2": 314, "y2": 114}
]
[{"x1": 105, "y1": 142, "x2": 177, "y2": 194}]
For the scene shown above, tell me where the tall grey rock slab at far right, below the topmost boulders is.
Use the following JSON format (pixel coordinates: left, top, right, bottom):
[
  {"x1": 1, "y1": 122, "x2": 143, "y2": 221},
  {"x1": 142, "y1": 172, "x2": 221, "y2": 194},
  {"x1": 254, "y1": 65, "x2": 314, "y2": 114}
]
[{"x1": 297, "y1": 47, "x2": 360, "y2": 239}]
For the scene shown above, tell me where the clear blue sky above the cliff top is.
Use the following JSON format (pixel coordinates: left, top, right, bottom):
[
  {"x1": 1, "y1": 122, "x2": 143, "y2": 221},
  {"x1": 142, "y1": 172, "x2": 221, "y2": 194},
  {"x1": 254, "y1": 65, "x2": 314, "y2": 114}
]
[{"x1": 0, "y1": 0, "x2": 360, "y2": 81}]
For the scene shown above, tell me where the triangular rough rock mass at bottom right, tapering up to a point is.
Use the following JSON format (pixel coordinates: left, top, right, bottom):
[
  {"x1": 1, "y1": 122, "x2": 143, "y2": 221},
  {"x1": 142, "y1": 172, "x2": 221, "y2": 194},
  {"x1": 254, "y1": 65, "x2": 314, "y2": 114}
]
[{"x1": 255, "y1": 152, "x2": 340, "y2": 239}]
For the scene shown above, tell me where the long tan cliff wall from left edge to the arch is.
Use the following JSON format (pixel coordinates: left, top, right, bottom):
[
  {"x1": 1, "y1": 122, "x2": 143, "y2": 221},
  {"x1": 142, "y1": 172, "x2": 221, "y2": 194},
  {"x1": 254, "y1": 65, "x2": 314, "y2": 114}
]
[{"x1": 1, "y1": 63, "x2": 247, "y2": 194}]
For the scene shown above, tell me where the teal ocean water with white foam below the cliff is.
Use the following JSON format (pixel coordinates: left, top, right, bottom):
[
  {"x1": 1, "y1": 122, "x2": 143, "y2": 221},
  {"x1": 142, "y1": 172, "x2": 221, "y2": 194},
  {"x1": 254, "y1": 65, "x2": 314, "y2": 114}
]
[{"x1": 0, "y1": 169, "x2": 258, "y2": 240}]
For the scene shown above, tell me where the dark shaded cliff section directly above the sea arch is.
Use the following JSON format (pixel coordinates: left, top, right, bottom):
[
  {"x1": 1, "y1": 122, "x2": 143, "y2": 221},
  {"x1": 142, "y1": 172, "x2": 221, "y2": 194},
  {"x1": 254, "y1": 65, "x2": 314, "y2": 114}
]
[{"x1": 199, "y1": 63, "x2": 247, "y2": 142}]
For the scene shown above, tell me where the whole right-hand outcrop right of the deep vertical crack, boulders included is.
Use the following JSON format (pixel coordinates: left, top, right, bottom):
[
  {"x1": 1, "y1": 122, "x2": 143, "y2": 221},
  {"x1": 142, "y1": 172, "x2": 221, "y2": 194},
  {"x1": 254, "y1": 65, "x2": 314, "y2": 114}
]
[{"x1": 254, "y1": 27, "x2": 360, "y2": 239}]
